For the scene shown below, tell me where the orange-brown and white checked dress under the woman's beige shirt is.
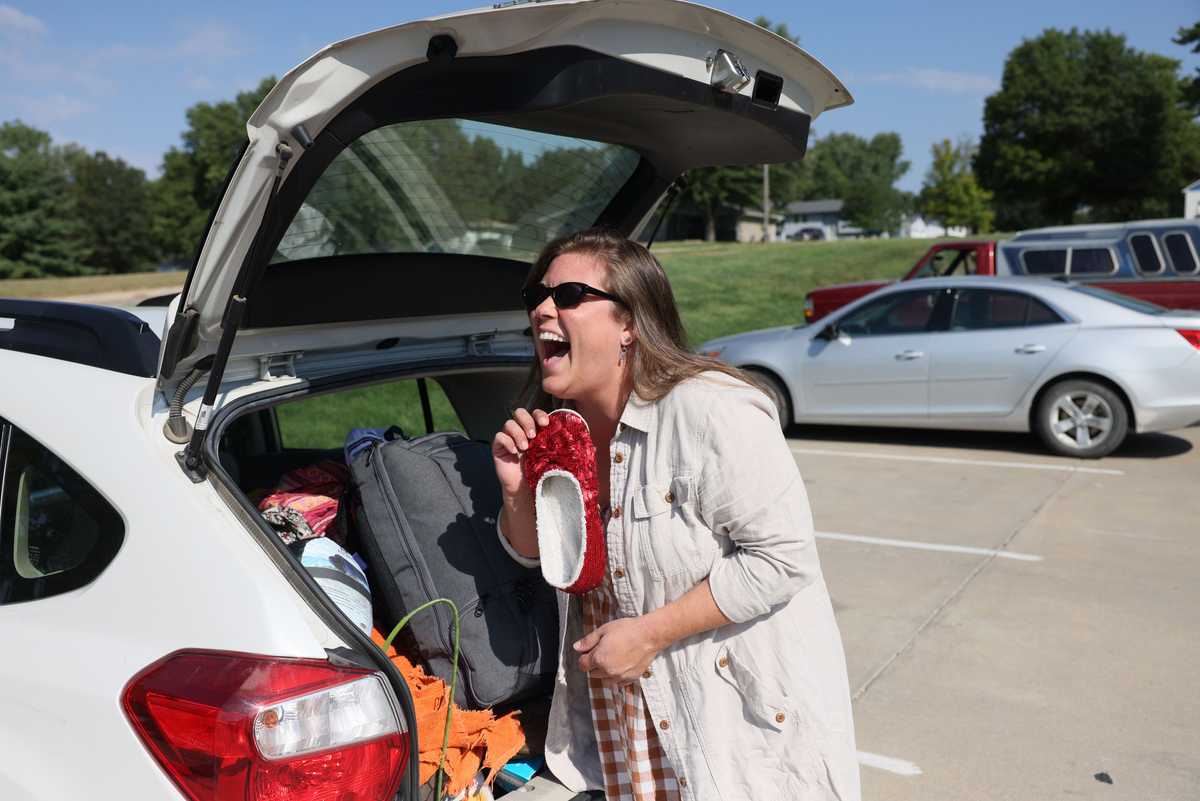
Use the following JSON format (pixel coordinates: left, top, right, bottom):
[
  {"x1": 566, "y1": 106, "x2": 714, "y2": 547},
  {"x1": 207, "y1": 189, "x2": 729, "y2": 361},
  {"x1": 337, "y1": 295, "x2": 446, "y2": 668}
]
[{"x1": 581, "y1": 572, "x2": 679, "y2": 801}]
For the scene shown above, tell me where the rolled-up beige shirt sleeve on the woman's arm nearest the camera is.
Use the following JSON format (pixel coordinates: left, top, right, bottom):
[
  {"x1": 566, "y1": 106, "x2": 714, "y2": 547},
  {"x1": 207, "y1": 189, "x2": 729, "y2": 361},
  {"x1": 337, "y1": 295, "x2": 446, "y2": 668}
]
[{"x1": 698, "y1": 387, "x2": 821, "y2": 622}]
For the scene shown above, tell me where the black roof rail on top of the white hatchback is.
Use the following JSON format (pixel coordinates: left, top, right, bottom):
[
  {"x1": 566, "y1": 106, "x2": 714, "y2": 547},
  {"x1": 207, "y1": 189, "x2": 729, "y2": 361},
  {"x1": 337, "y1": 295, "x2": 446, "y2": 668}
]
[{"x1": 0, "y1": 299, "x2": 160, "y2": 378}]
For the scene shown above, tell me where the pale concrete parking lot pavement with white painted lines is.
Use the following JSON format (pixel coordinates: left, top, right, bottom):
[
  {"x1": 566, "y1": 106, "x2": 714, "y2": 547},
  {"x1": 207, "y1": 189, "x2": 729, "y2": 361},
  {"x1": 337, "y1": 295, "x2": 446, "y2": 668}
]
[{"x1": 788, "y1": 427, "x2": 1200, "y2": 801}]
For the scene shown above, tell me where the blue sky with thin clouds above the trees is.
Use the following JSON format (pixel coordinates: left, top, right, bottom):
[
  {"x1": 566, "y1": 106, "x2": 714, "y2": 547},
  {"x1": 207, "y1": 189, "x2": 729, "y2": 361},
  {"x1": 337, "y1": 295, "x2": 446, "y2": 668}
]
[{"x1": 0, "y1": 0, "x2": 1200, "y2": 191}]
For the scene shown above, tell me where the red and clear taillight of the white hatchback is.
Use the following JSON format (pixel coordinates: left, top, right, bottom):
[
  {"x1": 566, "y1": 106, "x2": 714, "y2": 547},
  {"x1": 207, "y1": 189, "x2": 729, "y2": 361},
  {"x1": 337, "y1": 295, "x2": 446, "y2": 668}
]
[{"x1": 121, "y1": 651, "x2": 409, "y2": 801}]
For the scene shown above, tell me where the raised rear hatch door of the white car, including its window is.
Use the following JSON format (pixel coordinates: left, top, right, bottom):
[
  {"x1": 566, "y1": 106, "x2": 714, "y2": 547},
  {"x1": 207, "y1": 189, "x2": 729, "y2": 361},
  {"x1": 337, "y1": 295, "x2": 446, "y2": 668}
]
[{"x1": 158, "y1": 0, "x2": 852, "y2": 470}]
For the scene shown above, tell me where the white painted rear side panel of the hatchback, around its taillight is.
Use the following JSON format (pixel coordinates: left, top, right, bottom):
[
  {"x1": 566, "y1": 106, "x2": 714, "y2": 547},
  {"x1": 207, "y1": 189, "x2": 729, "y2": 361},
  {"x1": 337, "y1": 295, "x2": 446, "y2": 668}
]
[{"x1": 0, "y1": 350, "x2": 343, "y2": 801}]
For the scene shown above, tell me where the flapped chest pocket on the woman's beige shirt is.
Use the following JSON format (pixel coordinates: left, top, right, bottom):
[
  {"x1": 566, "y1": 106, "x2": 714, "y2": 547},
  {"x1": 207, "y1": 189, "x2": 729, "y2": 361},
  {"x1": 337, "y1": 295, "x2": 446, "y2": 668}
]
[{"x1": 632, "y1": 476, "x2": 708, "y2": 582}]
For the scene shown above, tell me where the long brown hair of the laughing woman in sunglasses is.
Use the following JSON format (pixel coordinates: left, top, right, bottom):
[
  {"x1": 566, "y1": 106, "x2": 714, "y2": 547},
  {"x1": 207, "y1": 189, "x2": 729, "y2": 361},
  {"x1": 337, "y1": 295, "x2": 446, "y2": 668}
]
[{"x1": 521, "y1": 228, "x2": 756, "y2": 409}]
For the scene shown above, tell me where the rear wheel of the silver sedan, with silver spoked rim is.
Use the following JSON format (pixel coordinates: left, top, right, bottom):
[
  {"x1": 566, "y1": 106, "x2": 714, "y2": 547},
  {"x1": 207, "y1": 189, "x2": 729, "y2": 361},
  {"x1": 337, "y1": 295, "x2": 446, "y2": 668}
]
[{"x1": 1033, "y1": 380, "x2": 1129, "y2": 459}]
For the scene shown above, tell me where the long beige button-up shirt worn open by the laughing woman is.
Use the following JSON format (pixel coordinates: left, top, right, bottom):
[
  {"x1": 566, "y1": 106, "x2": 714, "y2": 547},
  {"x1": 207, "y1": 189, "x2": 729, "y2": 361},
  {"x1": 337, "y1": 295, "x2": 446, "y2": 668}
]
[{"x1": 500, "y1": 372, "x2": 859, "y2": 801}]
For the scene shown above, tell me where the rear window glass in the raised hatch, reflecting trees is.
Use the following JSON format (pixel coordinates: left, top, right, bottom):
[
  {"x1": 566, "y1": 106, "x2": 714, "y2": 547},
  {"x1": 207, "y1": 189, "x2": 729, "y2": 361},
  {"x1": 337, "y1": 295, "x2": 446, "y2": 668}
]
[{"x1": 271, "y1": 120, "x2": 641, "y2": 264}]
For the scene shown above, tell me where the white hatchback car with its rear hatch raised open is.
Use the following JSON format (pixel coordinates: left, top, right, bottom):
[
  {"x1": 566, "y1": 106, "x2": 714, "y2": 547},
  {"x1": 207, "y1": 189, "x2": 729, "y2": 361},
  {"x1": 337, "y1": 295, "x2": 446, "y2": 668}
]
[{"x1": 0, "y1": 0, "x2": 851, "y2": 801}]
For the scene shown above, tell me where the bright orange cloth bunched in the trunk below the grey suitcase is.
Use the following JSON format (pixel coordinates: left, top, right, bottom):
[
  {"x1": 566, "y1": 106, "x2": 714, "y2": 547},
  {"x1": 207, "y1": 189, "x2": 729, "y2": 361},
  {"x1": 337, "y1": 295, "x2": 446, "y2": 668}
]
[{"x1": 371, "y1": 631, "x2": 524, "y2": 797}]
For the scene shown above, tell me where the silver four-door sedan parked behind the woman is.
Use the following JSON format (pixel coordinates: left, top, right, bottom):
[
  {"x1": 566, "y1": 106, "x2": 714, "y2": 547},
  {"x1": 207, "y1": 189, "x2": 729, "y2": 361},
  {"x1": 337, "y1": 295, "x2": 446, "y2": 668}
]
[{"x1": 700, "y1": 277, "x2": 1200, "y2": 458}]
